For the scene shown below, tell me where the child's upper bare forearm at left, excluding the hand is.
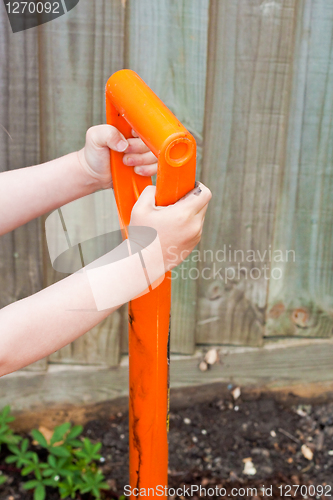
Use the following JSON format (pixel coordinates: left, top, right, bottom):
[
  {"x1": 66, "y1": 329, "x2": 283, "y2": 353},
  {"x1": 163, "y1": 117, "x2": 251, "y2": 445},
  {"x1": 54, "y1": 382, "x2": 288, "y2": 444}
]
[{"x1": 0, "y1": 152, "x2": 99, "y2": 235}]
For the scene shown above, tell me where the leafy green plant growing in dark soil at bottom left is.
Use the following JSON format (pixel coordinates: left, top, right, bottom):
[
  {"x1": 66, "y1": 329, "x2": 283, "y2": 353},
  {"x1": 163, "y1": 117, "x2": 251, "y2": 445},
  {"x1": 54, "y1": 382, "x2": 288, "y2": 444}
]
[{"x1": 0, "y1": 407, "x2": 109, "y2": 500}]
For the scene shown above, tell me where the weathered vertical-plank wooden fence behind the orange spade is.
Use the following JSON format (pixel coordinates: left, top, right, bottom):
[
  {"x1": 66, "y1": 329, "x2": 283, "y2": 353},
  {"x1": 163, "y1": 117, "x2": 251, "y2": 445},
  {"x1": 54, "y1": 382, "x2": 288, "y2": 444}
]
[{"x1": 0, "y1": 0, "x2": 333, "y2": 369}]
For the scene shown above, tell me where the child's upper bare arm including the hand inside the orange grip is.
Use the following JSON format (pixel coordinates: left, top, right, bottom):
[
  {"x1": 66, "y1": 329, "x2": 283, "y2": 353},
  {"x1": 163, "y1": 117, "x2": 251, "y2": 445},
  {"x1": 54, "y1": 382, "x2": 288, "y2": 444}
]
[{"x1": 0, "y1": 125, "x2": 156, "y2": 235}]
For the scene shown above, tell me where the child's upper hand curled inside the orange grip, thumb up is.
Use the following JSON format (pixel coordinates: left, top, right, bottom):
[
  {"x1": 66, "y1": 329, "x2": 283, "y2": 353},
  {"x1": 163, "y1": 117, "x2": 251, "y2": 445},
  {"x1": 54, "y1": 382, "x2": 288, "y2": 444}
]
[{"x1": 78, "y1": 125, "x2": 157, "y2": 189}]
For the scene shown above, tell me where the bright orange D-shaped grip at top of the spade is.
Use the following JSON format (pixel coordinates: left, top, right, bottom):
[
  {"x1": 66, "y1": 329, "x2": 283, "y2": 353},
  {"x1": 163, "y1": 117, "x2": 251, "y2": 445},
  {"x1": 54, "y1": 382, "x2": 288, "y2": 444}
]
[{"x1": 106, "y1": 69, "x2": 196, "y2": 226}]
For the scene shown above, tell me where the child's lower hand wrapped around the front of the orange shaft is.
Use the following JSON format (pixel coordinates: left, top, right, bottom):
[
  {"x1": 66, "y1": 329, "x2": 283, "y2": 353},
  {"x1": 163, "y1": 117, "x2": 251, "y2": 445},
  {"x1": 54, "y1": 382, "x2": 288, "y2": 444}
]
[{"x1": 131, "y1": 183, "x2": 212, "y2": 271}]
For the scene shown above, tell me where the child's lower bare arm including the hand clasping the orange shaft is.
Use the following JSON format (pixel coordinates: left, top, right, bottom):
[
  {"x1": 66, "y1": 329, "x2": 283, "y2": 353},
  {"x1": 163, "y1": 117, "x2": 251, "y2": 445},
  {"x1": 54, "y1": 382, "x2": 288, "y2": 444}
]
[{"x1": 0, "y1": 184, "x2": 211, "y2": 376}]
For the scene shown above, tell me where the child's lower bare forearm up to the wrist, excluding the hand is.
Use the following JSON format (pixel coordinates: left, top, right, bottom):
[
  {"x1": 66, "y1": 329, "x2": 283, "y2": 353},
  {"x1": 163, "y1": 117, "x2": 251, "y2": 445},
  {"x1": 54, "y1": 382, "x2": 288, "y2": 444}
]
[{"x1": 0, "y1": 242, "x2": 161, "y2": 376}]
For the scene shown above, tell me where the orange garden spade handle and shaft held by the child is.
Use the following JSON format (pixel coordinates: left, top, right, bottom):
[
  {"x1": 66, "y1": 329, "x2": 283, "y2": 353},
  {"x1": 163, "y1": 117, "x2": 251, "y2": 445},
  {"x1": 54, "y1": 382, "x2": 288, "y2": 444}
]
[{"x1": 106, "y1": 70, "x2": 196, "y2": 498}]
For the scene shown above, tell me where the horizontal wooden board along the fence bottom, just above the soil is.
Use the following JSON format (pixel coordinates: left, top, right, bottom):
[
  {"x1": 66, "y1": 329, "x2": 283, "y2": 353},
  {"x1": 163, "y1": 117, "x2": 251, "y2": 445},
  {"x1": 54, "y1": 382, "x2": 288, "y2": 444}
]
[{"x1": 0, "y1": 340, "x2": 333, "y2": 416}]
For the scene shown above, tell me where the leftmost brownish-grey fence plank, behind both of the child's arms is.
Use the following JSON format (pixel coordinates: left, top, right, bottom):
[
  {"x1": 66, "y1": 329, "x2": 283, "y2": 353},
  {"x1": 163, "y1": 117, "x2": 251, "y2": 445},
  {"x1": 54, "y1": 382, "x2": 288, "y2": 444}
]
[{"x1": 0, "y1": 13, "x2": 46, "y2": 370}]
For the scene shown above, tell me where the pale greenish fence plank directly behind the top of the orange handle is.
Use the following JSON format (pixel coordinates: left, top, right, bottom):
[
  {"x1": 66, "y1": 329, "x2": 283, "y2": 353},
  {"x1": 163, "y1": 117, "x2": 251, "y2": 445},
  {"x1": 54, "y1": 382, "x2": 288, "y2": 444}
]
[{"x1": 126, "y1": 0, "x2": 209, "y2": 353}]
